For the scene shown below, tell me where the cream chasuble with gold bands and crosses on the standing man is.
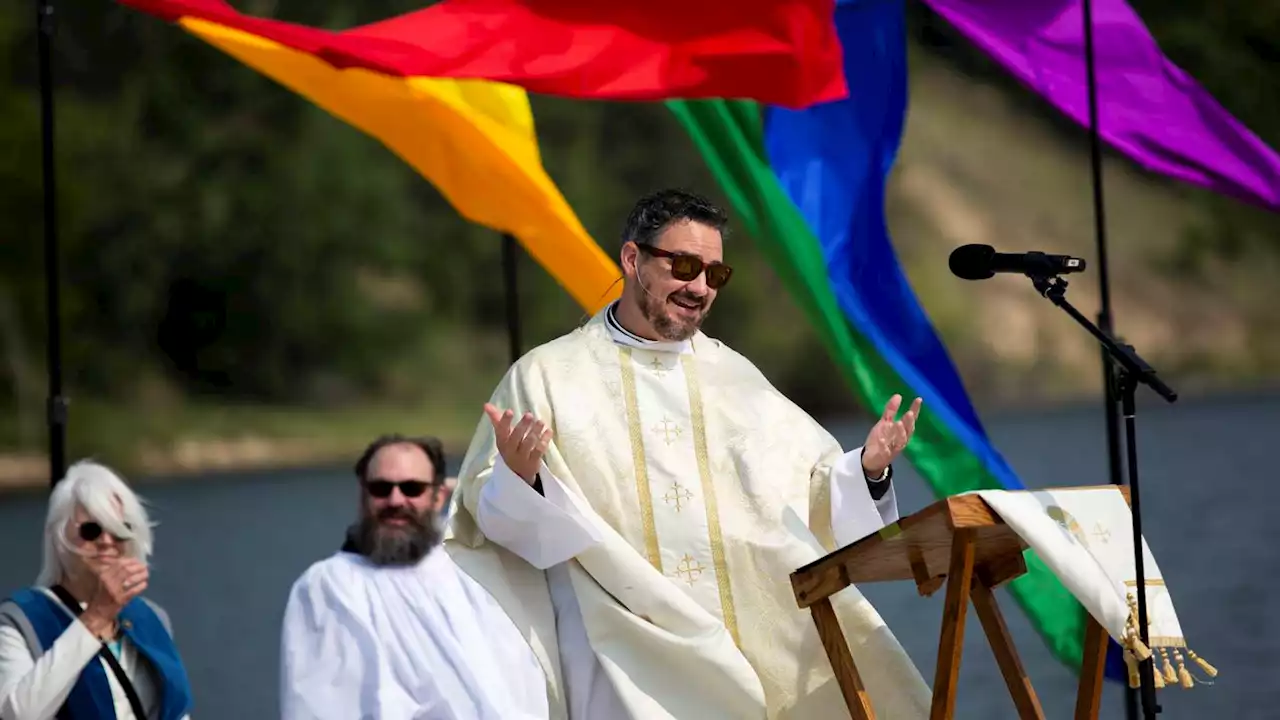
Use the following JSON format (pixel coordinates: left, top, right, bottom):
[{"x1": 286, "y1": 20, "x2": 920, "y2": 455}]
[{"x1": 447, "y1": 311, "x2": 929, "y2": 720}]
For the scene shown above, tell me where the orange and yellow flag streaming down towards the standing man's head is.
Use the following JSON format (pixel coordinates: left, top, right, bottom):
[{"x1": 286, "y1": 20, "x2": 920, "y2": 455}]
[{"x1": 178, "y1": 17, "x2": 621, "y2": 313}]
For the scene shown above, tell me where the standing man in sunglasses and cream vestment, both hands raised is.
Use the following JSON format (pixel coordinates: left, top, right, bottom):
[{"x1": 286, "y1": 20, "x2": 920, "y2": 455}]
[{"x1": 447, "y1": 191, "x2": 929, "y2": 720}]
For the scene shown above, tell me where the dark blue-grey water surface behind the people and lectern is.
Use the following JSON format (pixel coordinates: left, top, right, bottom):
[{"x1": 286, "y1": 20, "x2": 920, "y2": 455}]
[{"x1": 0, "y1": 396, "x2": 1280, "y2": 720}]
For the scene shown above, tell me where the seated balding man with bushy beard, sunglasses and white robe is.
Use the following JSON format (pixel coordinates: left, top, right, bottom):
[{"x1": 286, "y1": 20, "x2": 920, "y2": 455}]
[{"x1": 280, "y1": 436, "x2": 549, "y2": 720}]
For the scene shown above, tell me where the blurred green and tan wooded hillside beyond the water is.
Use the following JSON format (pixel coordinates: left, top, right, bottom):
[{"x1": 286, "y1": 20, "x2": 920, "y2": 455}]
[{"x1": 0, "y1": 0, "x2": 1280, "y2": 477}]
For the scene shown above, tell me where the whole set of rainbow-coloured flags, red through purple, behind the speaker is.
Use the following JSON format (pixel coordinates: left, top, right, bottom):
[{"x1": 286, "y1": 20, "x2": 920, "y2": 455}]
[{"x1": 120, "y1": 0, "x2": 1280, "y2": 680}]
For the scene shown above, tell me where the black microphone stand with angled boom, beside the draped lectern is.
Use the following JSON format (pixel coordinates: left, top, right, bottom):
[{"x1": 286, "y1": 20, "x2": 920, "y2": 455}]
[{"x1": 1027, "y1": 273, "x2": 1178, "y2": 720}]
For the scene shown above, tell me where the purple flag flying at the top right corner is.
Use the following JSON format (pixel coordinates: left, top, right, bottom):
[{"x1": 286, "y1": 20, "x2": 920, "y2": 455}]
[{"x1": 925, "y1": 0, "x2": 1280, "y2": 210}]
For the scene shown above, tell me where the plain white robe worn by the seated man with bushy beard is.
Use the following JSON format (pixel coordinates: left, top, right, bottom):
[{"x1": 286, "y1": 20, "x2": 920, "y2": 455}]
[{"x1": 280, "y1": 548, "x2": 549, "y2": 720}]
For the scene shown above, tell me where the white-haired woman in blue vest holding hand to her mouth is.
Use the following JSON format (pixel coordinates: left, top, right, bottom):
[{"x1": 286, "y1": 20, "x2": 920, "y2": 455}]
[{"x1": 0, "y1": 461, "x2": 191, "y2": 720}]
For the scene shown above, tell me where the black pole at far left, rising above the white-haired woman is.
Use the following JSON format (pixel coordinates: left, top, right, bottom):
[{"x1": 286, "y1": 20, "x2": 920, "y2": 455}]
[{"x1": 36, "y1": 0, "x2": 67, "y2": 487}]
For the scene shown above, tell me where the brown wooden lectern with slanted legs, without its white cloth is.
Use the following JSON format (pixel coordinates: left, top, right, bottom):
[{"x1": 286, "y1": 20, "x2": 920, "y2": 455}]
[{"x1": 791, "y1": 487, "x2": 1129, "y2": 720}]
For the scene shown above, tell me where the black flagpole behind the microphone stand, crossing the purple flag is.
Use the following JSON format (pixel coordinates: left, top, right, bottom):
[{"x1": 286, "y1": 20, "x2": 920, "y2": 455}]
[{"x1": 1083, "y1": 0, "x2": 1138, "y2": 720}]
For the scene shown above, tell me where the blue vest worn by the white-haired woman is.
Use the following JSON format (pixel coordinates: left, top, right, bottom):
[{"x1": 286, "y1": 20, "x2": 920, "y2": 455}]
[{"x1": 9, "y1": 588, "x2": 191, "y2": 720}]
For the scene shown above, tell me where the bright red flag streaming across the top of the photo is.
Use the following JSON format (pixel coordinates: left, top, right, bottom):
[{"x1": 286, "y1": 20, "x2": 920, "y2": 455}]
[{"x1": 120, "y1": 0, "x2": 847, "y2": 108}]
